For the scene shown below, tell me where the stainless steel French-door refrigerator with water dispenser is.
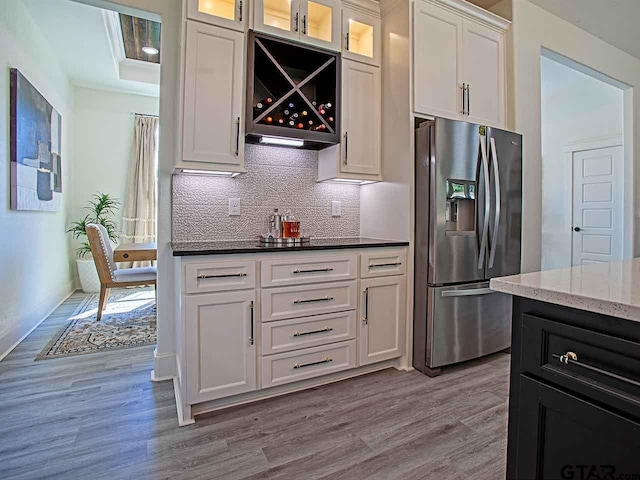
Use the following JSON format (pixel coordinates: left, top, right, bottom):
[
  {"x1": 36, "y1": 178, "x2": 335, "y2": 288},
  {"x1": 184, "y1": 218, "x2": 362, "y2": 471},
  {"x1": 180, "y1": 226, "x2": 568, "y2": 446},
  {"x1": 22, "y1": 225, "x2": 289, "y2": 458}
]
[{"x1": 413, "y1": 118, "x2": 522, "y2": 375}]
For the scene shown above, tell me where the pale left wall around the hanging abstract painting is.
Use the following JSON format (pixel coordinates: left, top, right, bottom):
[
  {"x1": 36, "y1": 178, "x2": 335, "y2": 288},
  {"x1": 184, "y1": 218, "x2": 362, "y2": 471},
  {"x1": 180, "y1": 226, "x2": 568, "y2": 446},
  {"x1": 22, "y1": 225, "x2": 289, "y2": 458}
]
[{"x1": 0, "y1": 0, "x2": 74, "y2": 358}]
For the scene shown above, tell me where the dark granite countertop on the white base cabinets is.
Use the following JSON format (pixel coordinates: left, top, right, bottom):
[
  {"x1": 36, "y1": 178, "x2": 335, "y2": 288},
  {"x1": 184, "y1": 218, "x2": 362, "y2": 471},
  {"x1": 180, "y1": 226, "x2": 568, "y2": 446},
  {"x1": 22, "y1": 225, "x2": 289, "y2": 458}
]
[{"x1": 171, "y1": 237, "x2": 409, "y2": 257}]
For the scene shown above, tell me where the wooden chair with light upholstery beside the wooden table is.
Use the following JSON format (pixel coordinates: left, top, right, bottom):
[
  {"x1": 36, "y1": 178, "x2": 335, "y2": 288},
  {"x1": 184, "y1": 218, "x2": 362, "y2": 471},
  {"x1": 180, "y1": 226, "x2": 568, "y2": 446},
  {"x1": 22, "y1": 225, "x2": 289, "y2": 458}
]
[{"x1": 86, "y1": 223, "x2": 158, "y2": 321}]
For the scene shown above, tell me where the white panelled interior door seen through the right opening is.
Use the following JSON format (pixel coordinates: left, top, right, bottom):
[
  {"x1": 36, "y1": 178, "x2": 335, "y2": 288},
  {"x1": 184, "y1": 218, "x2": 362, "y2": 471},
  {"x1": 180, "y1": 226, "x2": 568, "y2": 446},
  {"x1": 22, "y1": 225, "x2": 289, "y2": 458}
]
[{"x1": 572, "y1": 146, "x2": 624, "y2": 266}]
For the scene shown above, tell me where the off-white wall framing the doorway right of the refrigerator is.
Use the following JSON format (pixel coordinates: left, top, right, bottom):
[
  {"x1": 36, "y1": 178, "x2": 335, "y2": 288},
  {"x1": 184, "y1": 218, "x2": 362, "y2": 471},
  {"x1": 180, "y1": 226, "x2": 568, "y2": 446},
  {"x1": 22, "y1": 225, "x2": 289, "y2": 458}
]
[{"x1": 509, "y1": 0, "x2": 640, "y2": 272}]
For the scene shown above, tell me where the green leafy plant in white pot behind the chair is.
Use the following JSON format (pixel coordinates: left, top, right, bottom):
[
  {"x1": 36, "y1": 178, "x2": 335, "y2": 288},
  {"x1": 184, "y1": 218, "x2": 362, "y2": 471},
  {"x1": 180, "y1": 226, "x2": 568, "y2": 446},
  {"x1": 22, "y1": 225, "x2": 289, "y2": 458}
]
[{"x1": 67, "y1": 193, "x2": 120, "y2": 293}]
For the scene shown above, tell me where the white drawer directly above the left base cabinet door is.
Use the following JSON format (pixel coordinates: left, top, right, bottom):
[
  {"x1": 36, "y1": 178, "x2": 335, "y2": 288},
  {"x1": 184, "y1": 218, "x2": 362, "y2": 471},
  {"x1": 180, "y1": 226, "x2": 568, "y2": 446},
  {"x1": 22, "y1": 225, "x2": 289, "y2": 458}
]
[{"x1": 185, "y1": 260, "x2": 256, "y2": 294}]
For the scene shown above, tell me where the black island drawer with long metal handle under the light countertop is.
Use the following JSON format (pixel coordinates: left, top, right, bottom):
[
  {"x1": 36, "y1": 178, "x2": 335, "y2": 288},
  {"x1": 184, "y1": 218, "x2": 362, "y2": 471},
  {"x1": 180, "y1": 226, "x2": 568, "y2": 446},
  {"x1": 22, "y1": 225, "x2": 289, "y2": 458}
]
[{"x1": 520, "y1": 314, "x2": 640, "y2": 418}]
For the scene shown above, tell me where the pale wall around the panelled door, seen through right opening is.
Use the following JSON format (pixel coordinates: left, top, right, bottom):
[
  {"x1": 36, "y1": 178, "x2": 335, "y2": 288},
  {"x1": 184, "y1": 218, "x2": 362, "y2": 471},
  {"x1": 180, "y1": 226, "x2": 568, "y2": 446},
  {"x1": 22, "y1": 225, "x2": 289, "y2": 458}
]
[{"x1": 541, "y1": 57, "x2": 623, "y2": 270}]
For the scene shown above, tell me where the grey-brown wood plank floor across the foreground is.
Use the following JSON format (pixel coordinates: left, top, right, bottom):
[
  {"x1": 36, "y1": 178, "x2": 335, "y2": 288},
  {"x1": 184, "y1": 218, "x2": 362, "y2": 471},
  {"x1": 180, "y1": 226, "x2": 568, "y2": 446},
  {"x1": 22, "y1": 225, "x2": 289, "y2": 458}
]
[{"x1": 0, "y1": 294, "x2": 509, "y2": 480}]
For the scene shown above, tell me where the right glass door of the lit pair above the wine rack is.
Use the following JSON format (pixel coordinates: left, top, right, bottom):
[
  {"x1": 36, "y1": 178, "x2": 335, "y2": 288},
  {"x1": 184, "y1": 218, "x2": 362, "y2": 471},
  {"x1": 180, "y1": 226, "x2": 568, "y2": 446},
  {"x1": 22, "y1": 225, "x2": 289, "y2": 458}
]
[{"x1": 300, "y1": 0, "x2": 341, "y2": 51}]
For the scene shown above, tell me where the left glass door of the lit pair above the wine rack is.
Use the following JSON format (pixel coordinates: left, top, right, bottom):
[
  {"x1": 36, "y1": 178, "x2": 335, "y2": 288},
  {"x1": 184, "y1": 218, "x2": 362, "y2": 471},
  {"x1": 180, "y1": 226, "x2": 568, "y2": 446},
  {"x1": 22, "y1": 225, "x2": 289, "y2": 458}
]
[{"x1": 254, "y1": 0, "x2": 302, "y2": 40}]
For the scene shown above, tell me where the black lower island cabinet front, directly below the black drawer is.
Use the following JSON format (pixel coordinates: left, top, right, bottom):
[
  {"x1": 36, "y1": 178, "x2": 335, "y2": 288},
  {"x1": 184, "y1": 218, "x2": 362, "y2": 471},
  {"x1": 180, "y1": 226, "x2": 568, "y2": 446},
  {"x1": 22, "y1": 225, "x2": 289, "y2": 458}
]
[{"x1": 508, "y1": 375, "x2": 640, "y2": 480}]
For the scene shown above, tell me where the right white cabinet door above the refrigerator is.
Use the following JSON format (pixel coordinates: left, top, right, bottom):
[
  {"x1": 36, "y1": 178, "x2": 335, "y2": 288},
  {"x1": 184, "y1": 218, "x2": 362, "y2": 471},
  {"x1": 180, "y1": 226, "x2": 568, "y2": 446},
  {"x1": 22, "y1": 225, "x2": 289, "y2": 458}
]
[{"x1": 463, "y1": 21, "x2": 505, "y2": 127}]
